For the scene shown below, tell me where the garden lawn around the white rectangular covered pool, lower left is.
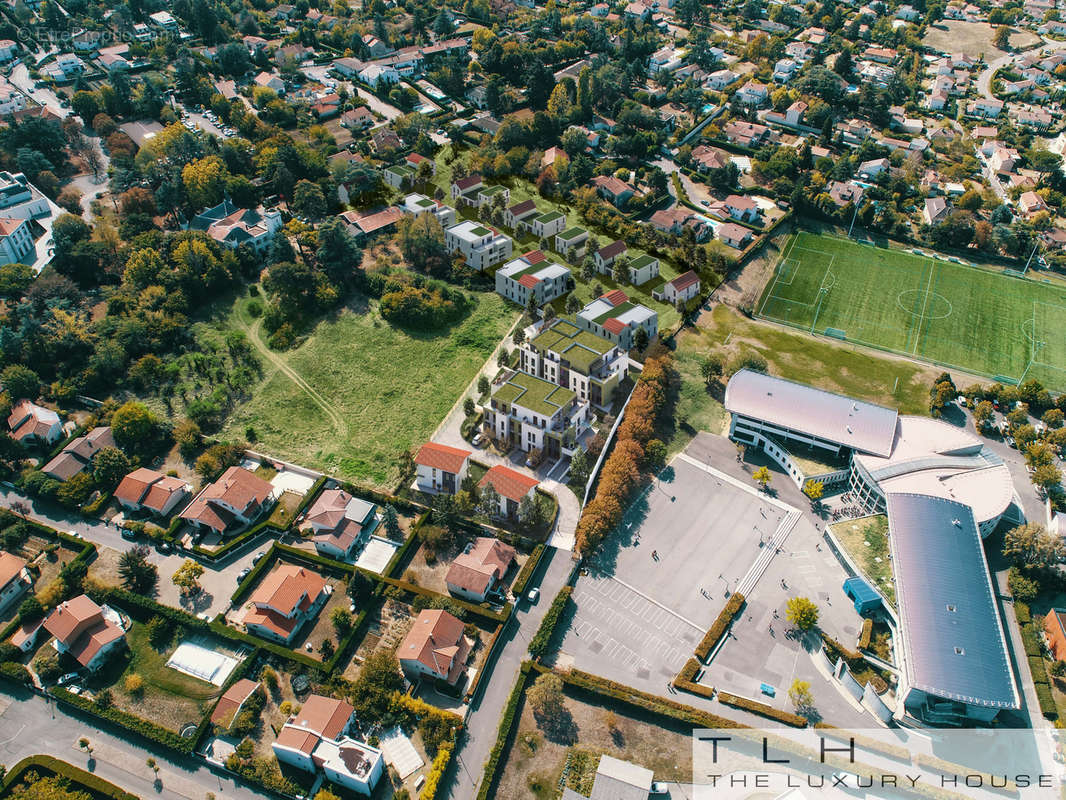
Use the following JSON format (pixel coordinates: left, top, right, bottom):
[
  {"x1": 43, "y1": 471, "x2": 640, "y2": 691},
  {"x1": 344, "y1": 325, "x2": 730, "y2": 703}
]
[{"x1": 90, "y1": 620, "x2": 221, "y2": 732}]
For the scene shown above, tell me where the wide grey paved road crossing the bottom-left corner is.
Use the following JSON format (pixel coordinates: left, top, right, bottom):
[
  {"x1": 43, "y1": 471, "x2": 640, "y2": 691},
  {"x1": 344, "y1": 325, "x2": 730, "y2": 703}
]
[{"x1": 0, "y1": 685, "x2": 263, "y2": 800}]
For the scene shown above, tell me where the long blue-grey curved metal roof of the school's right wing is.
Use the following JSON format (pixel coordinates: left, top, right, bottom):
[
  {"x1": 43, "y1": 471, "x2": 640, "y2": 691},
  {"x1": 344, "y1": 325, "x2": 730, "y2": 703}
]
[{"x1": 886, "y1": 494, "x2": 1019, "y2": 708}]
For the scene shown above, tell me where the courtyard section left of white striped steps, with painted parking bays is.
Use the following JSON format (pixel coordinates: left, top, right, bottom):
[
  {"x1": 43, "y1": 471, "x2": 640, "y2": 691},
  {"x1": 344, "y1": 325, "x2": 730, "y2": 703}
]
[{"x1": 561, "y1": 458, "x2": 788, "y2": 686}]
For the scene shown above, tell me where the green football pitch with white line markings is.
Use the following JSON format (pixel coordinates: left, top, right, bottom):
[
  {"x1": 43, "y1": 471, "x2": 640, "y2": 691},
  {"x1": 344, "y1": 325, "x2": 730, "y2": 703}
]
[{"x1": 756, "y1": 233, "x2": 1066, "y2": 391}]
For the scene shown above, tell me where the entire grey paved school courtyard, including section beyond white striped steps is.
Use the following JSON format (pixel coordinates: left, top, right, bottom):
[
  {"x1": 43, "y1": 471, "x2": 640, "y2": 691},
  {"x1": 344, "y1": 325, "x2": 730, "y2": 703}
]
[{"x1": 559, "y1": 434, "x2": 873, "y2": 726}]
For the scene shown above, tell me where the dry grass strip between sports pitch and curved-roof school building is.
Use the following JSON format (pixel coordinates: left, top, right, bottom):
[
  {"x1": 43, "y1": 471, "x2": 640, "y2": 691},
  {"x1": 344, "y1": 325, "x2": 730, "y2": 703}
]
[{"x1": 668, "y1": 305, "x2": 936, "y2": 454}]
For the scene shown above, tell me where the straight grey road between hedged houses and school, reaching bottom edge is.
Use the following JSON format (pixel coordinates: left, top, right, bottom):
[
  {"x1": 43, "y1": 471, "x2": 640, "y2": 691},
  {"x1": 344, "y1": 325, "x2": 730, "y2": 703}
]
[{"x1": 445, "y1": 548, "x2": 572, "y2": 800}]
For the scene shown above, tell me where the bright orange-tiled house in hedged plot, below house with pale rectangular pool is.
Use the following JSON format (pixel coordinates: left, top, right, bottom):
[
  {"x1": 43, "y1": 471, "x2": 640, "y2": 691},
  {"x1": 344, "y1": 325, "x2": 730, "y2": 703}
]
[{"x1": 244, "y1": 563, "x2": 329, "y2": 644}]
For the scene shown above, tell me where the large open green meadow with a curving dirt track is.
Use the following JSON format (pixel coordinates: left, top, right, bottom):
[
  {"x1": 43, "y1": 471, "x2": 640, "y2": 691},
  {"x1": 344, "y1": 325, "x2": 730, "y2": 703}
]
[{"x1": 222, "y1": 292, "x2": 518, "y2": 490}]
